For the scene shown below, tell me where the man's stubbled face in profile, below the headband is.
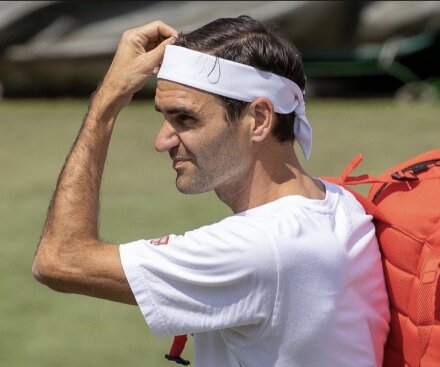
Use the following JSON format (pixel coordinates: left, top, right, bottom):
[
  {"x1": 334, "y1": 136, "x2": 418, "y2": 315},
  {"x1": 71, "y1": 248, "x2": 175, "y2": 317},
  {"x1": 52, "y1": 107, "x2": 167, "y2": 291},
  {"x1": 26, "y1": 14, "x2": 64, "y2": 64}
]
[{"x1": 155, "y1": 80, "x2": 251, "y2": 194}]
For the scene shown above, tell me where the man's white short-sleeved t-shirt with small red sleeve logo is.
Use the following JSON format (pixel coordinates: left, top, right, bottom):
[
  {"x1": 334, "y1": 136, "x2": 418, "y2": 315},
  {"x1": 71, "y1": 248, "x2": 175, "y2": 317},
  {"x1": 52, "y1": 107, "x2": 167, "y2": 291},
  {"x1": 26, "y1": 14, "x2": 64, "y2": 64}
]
[{"x1": 120, "y1": 182, "x2": 389, "y2": 367}]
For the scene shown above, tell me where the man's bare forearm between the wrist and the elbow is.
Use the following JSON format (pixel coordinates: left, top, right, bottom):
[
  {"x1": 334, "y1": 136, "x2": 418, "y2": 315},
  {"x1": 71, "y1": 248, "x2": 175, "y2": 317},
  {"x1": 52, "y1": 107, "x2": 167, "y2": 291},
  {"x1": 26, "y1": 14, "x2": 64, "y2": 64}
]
[{"x1": 42, "y1": 91, "x2": 119, "y2": 244}]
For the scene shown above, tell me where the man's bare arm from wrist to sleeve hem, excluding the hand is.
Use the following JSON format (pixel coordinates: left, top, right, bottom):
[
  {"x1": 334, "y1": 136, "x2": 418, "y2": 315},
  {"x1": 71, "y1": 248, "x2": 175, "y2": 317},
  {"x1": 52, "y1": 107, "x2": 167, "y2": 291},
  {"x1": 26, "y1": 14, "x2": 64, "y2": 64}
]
[{"x1": 33, "y1": 89, "x2": 135, "y2": 303}]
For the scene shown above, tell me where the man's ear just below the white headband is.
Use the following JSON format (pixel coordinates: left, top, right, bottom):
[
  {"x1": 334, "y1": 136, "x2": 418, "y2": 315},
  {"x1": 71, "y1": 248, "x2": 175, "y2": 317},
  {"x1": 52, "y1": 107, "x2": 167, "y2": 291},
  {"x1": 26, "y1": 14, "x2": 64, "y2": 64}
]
[{"x1": 249, "y1": 97, "x2": 275, "y2": 142}]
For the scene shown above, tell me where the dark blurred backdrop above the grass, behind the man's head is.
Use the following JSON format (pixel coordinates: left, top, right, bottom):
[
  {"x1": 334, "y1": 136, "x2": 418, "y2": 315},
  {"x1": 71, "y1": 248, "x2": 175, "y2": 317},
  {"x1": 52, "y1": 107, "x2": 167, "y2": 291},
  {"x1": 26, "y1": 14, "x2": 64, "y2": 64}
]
[{"x1": 0, "y1": 0, "x2": 440, "y2": 98}]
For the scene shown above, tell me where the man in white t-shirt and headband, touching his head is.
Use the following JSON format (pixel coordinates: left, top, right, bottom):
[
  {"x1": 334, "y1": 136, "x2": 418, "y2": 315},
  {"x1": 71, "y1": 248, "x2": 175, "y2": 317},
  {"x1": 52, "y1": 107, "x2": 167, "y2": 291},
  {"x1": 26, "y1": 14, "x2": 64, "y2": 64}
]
[{"x1": 33, "y1": 16, "x2": 389, "y2": 367}]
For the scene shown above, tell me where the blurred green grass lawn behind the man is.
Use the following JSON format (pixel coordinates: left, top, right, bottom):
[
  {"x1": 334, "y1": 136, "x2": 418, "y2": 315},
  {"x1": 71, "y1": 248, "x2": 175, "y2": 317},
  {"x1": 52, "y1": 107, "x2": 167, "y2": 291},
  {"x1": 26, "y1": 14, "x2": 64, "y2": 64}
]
[{"x1": 0, "y1": 99, "x2": 440, "y2": 367}]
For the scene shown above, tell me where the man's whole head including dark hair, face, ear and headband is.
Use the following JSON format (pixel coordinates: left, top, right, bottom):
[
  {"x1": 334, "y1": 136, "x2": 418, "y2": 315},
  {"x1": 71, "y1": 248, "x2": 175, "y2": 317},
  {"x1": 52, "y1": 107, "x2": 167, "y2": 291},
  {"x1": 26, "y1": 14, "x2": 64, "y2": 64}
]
[{"x1": 155, "y1": 16, "x2": 305, "y2": 198}]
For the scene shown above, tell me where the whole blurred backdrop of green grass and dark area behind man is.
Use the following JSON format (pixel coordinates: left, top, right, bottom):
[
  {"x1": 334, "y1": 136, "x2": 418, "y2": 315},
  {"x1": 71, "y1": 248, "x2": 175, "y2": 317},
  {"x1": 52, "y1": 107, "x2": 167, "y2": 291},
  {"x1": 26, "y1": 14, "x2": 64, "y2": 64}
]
[{"x1": 0, "y1": 0, "x2": 440, "y2": 367}]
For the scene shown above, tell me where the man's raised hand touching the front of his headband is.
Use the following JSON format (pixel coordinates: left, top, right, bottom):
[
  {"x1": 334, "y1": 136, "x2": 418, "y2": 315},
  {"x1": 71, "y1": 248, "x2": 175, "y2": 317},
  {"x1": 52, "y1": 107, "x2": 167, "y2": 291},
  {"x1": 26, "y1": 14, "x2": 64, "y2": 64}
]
[{"x1": 100, "y1": 21, "x2": 177, "y2": 108}]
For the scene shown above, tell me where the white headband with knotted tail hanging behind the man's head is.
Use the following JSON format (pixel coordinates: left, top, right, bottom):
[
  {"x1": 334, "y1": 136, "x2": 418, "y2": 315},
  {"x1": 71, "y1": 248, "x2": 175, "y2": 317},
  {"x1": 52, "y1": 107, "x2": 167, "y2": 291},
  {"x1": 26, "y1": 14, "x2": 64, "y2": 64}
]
[{"x1": 157, "y1": 45, "x2": 312, "y2": 159}]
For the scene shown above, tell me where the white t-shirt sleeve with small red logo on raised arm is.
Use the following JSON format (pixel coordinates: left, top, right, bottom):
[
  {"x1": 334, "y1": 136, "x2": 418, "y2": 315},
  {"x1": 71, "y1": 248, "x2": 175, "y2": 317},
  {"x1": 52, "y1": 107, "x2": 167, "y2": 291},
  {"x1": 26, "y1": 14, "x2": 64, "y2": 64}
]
[{"x1": 120, "y1": 216, "x2": 278, "y2": 336}]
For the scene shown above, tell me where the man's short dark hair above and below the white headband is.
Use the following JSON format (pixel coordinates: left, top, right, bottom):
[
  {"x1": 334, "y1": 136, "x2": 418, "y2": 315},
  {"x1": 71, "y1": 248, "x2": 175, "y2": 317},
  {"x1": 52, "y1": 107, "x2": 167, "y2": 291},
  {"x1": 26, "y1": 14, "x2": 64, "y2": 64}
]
[{"x1": 174, "y1": 16, "x2": 306, "y2": 142}]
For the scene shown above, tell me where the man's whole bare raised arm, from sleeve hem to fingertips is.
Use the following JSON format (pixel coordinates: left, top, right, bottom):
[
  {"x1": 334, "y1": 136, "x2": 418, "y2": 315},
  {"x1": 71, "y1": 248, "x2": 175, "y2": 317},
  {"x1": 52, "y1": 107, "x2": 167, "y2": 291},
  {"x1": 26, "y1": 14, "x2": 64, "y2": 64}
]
[{"x1": 32, "y1": 21, "x2": 176, "y2": 304}]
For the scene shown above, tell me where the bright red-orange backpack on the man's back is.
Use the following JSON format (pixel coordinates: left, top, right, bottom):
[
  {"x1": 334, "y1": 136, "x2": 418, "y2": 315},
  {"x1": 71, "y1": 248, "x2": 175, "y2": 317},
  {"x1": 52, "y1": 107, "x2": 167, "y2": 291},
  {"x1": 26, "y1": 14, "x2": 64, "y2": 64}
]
[{"x1": 325, "y1": 149, "x2": 440, "y2": 367}]
